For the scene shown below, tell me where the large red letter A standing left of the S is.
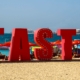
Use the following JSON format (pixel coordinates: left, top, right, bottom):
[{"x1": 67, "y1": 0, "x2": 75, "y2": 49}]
[{"x1": 8, "y1": 28, "x2": 30, "y2": 61}]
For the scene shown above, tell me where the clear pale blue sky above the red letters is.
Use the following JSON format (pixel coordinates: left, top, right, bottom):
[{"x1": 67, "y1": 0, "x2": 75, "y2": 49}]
[{"x1": 0, "y1": 0, "x2": 80, "y2": 33}]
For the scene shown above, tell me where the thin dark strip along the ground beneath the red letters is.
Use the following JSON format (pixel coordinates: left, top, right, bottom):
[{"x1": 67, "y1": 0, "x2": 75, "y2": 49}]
[{"x1": 0, "y1": 58, "x2": 80, "y2": 63}]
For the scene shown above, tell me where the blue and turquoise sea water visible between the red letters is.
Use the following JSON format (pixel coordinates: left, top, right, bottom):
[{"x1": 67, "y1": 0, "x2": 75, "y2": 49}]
[{"x1": 0, "y1": 33, "x2": 80, "y2": 56}]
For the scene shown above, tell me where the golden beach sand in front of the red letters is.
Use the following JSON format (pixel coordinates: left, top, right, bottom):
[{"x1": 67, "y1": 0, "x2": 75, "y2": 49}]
[{"x1": 0, "y1": 61, "x2": 80, "y2": 80}]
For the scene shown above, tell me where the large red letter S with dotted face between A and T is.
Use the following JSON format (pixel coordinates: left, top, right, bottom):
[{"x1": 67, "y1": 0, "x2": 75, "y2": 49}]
[{"x1": 34, "y1": 28, "x2": 53, "y2": 60}]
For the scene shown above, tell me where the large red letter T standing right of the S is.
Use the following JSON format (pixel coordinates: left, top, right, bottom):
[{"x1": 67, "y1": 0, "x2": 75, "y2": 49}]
[{"x1": 57, "y1": 29, "x2": 76, "y2": 60}]
